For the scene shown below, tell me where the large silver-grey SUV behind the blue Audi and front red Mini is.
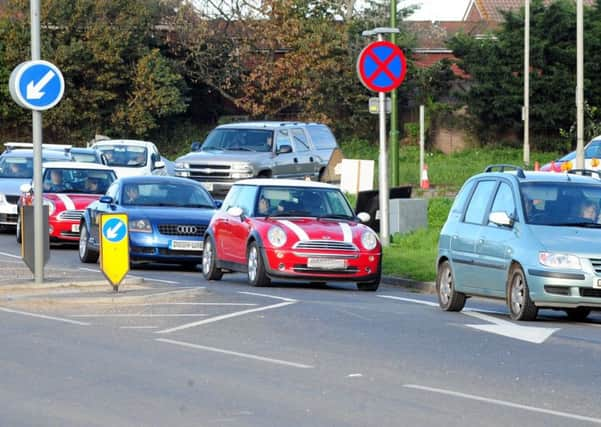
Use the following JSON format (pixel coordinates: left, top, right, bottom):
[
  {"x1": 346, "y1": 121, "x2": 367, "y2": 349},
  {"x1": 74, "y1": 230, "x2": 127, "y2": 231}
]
[{"x1": 175, "y1": 122, "x2": 337, "y2": 193}]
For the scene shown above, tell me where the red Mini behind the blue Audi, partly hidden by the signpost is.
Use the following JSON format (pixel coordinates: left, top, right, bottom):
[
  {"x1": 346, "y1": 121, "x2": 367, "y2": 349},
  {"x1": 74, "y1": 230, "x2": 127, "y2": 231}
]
[{"x1": 16, "y1": 162, "x2": 117, "y2": 243}]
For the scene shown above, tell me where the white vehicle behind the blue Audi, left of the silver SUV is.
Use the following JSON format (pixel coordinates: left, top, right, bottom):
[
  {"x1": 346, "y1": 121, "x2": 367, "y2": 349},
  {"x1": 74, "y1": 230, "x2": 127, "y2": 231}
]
[{"x1": 92, "y1": 139, "x2": 167, "y2": 178}]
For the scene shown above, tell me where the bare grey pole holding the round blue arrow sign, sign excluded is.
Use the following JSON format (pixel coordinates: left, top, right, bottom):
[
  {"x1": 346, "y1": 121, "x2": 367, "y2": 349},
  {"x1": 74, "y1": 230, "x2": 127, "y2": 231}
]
[{"x1": 31, "y1": 0, "x2": 46, "y2": 284}]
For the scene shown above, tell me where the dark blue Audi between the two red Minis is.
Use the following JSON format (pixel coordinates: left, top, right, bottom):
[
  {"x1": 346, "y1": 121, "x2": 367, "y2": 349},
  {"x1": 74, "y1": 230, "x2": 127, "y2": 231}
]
[{"x1": 79, "y1": 175, "x2": 221, "y2": 267}]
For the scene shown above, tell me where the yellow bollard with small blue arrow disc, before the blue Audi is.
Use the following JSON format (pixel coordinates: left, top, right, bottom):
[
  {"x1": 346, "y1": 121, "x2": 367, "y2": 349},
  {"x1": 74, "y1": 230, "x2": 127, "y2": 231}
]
[{"x1": 98, "y1": 213, "x2": 129, "y2": 290}]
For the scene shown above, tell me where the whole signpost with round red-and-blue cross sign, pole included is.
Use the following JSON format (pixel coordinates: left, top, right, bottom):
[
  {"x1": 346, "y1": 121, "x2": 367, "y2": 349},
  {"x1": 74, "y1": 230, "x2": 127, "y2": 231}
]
[{"x1": 357, "y1": 28, "x2": 407, "y2": 246}]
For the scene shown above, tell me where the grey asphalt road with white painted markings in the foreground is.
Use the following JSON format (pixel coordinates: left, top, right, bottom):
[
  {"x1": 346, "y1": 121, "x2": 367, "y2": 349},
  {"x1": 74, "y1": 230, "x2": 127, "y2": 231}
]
[{"x1": 0, "y1": 235, "x2": 601, "y2": 427}]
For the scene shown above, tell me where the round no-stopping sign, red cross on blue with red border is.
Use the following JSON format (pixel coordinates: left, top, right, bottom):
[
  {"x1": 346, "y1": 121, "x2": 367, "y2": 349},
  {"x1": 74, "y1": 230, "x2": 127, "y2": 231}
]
[{"x1": 357, "y1": 40, "x2": 407, "y2": 92}]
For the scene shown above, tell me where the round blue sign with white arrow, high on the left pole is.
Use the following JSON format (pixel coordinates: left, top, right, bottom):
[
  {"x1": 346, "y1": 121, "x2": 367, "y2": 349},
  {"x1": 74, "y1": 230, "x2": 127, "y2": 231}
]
[{"x1": 9, "y1": 60, "x2": 65, "y2": 111}]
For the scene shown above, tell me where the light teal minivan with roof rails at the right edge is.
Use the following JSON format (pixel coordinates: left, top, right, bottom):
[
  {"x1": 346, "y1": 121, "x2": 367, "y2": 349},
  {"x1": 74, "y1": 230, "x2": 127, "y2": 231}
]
[{"x1": 436, "y1": 165, "x2": 601, "y2": 320}]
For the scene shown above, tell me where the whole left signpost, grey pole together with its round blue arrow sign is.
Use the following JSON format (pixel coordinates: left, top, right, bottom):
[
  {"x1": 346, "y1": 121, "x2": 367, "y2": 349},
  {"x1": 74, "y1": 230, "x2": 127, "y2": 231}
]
[{"x1": 9, "y1": 0, "x2": 65, "y2": 284}]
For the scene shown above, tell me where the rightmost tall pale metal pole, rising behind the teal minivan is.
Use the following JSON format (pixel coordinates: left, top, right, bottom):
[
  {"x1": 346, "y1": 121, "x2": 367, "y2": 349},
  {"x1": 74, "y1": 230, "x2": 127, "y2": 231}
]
[{"x1": 576, "y1": 0, "x2": 584, "y2": 169}]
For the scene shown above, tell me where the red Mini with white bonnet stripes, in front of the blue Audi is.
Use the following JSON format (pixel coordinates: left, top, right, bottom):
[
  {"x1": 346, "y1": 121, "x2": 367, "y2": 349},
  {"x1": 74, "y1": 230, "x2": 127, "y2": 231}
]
[{"x1": 202, "y1": 179, "x2": 382, "y2": 291}]
